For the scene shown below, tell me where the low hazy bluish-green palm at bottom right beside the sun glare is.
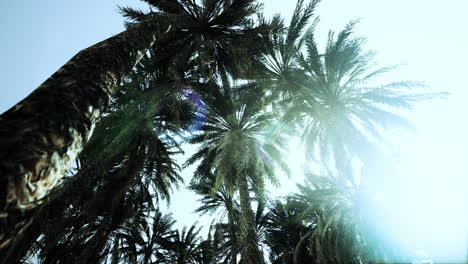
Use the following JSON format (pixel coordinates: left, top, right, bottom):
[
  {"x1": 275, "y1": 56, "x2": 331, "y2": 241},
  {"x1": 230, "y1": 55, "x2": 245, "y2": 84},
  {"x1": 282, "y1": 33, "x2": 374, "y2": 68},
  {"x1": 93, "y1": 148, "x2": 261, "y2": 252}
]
[{"x1": 289, "y1": 174, "x2": 397, "y2": 264}]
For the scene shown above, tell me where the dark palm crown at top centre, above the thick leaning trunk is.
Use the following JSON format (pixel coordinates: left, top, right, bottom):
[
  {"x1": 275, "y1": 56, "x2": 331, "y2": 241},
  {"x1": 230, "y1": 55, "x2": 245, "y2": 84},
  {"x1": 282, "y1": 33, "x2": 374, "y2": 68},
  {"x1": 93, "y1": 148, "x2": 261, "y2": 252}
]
[{"x1": 121, "y1": 0, "x2": 267, "y2": 78}]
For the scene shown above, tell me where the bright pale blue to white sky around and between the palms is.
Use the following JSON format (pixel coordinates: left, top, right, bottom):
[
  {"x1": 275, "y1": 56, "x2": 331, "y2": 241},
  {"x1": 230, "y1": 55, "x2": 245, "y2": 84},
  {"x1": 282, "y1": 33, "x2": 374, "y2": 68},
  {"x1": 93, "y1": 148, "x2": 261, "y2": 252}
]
[{"x1": 0, "y1": 0, "x2": 468, "y2": 259}]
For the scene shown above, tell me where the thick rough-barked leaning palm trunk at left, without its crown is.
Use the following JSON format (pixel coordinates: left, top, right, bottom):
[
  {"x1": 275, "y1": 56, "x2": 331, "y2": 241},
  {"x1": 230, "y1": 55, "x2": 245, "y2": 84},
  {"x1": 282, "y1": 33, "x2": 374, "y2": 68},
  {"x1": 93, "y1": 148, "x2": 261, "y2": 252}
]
[{"x1": 0, "y1": 20, "x2": 167, "y2": 248}]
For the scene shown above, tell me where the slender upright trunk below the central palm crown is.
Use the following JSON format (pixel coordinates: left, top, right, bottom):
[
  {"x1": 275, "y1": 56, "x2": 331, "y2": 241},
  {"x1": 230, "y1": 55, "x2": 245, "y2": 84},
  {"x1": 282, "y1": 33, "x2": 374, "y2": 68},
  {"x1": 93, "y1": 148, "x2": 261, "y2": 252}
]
[{"x1": 239, "y1": 173, "x2": 263, "y2": 264}]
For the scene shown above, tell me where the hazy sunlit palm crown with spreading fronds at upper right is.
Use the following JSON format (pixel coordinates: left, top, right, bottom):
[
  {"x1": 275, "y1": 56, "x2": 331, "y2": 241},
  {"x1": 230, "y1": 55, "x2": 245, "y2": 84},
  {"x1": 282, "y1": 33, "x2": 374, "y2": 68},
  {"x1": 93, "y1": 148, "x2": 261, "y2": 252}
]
[{"x1": 286, "y1": 22, "x2": 441, "y2": 184}]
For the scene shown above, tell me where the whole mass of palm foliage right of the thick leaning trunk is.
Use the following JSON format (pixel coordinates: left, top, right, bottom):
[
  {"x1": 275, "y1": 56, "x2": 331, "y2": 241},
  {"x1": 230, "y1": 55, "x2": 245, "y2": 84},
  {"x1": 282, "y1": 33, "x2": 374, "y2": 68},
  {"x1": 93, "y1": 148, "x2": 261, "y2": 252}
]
[{"x1": 4, "y1": 0, "x2": 441, "y2": 264}]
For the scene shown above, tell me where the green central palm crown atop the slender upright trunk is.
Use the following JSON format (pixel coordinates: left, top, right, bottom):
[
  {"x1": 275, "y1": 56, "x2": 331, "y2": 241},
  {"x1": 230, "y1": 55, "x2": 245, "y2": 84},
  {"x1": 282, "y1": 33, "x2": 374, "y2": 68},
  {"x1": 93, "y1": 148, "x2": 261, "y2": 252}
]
[{"x1": 185, "y1": 79, "x2": 288, "y2": 191}]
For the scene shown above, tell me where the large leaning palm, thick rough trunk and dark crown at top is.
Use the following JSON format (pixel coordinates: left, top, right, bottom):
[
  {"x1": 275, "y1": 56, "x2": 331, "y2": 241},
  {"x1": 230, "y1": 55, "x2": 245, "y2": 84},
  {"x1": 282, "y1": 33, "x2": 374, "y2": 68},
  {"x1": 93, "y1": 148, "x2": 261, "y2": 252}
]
[{"x1": 0, "y1": 0, "x2": 264, "y2": 217}]
